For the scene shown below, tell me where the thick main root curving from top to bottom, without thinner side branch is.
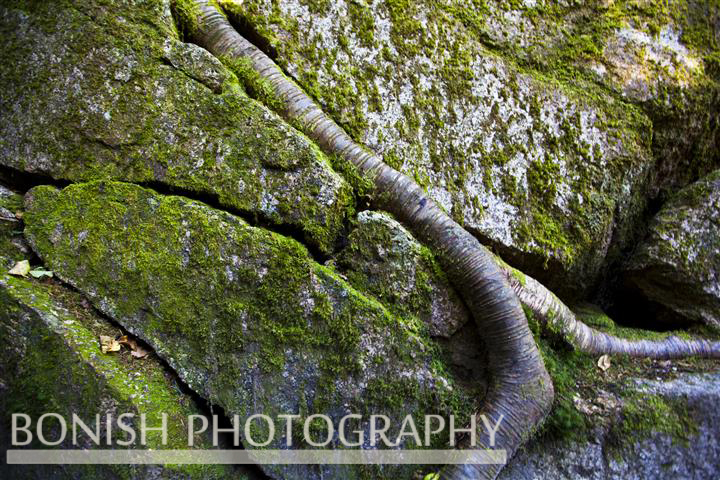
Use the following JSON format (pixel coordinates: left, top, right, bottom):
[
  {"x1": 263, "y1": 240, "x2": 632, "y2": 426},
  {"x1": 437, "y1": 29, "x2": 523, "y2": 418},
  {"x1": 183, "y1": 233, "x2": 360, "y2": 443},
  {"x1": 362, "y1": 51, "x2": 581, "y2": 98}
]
[{"x1": 185, "y1": 0, "x2": 553, "y2": 480}]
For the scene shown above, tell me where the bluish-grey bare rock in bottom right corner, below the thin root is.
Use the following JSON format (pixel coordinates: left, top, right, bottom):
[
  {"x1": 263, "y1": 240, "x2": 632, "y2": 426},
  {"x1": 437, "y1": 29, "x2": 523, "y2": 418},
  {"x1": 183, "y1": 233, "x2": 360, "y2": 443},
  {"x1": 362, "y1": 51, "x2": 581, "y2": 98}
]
[{"x1": 500, "y1": 373, "x2": 720, "y2": 480}]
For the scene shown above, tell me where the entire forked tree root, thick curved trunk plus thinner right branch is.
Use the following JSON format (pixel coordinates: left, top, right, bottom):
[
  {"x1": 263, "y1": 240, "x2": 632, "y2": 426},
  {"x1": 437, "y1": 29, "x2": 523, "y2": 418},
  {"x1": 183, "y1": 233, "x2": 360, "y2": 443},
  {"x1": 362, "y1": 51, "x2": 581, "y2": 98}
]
[{"x1": 175, "y1": 0, "x2": 720, "y2": 480}]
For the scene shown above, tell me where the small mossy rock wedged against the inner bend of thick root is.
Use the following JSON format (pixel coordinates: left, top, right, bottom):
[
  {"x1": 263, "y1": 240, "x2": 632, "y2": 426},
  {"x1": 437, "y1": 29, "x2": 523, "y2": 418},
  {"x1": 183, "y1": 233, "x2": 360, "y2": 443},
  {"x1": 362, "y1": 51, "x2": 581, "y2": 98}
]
[{"x1": 336, "y1": 211, "x2": 488, "y2": 390}]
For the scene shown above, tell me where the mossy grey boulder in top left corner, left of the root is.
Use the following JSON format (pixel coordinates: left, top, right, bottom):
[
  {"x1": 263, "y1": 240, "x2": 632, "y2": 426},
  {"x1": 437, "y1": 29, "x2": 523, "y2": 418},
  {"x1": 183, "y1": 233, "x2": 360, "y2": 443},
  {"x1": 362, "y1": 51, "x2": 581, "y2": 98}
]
[{"x1": 0, "y1": 0, "x2": 352, "y2": 251}]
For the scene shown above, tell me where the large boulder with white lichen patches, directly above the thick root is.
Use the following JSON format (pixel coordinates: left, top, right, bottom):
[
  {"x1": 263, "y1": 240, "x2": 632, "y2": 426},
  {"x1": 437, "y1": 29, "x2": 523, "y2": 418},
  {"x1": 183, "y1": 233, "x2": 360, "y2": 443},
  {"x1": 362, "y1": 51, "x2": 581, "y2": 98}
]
[{"x1": 220, "y1": 0, "x2": 652, "y2": 294}]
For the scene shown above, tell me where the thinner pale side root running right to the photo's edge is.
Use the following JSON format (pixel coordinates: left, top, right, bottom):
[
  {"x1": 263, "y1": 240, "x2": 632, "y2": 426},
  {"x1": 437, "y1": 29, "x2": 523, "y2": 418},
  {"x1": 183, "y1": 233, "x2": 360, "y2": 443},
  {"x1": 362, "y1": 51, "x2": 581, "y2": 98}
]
[{"x1": 498, "y1": 261, "x2": 720, "y2": 359}]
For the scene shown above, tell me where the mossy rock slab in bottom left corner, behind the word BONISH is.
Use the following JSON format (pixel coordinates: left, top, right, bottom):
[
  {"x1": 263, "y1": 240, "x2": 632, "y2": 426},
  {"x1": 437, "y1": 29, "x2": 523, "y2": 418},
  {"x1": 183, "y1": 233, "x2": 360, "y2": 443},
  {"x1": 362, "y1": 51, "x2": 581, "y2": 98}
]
[{"x1": 0, "y1": 269, "x2": 245, "y2": 479}]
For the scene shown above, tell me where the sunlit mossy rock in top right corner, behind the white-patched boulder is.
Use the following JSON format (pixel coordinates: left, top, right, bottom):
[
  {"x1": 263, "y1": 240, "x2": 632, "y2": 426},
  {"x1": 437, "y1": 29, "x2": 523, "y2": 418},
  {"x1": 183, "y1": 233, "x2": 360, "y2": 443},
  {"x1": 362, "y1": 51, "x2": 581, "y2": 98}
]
[{"x1": 465, "y1": 0, "x2": 720, "y2": 197}]
